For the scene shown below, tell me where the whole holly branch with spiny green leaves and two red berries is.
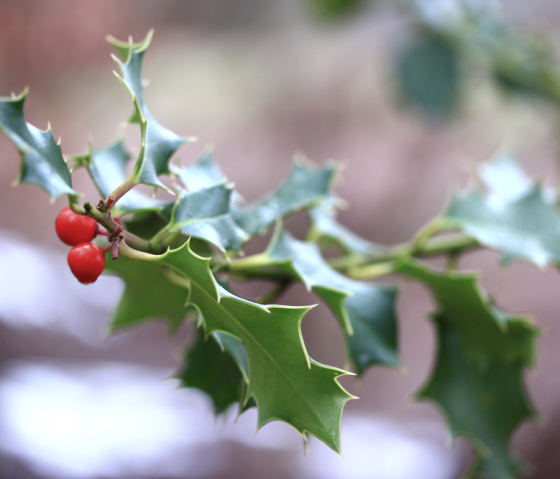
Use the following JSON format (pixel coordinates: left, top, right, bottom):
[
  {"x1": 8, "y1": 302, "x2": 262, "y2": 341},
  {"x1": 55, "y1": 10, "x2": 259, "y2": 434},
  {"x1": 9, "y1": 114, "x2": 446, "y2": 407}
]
[{"x1": 0, "y1": 33, "x2": 560, "y2": 479}]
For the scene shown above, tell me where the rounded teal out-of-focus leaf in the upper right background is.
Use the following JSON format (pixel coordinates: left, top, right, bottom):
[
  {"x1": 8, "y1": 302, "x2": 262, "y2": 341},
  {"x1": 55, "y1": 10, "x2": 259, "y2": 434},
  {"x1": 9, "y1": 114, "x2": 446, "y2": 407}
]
[{"x1": 396, "y1": 34, "x2": 459, "y2": 116}]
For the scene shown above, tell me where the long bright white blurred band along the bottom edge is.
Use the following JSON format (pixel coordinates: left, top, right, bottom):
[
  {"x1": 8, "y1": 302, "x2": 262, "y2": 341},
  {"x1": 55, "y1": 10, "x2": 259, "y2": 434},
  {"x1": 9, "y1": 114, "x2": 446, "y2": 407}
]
[{"x1": 0, "y1": 362, "x2": 460, "y2": 479}]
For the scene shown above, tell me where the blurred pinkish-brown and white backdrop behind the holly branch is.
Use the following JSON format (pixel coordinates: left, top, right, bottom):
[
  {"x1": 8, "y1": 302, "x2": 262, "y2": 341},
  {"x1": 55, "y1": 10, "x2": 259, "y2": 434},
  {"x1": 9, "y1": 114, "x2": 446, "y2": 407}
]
[{"x1": 0, "y1": 0, "x2": 560, "y2": 479}]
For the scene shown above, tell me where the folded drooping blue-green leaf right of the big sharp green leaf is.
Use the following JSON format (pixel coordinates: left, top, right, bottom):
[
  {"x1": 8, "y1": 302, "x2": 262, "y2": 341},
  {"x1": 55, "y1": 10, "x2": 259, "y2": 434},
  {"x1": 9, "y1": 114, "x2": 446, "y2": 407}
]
[{"x1": 239, "y1": 227, "x2": 399, "y2": 375}]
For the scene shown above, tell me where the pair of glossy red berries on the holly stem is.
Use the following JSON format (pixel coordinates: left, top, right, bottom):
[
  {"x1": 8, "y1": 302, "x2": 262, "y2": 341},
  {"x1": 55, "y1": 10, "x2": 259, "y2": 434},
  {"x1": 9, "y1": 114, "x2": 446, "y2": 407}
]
[{"x1": 55, "y1": 206, "x2": 105, "y2": 284}]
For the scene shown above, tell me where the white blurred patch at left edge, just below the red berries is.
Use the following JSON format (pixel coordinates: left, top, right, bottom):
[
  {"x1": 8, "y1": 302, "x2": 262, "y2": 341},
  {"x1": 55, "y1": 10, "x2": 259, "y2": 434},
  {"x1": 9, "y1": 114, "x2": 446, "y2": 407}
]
[{"x1": 0, "y1": 230, "x2": 123, "y2": 342}]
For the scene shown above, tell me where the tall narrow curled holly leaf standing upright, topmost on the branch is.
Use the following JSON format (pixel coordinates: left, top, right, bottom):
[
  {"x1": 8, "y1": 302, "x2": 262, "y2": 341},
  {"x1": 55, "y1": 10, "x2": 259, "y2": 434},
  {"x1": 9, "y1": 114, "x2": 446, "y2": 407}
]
[{"x1": 108, "y1": 31, "x2": 193, "y2": 190}]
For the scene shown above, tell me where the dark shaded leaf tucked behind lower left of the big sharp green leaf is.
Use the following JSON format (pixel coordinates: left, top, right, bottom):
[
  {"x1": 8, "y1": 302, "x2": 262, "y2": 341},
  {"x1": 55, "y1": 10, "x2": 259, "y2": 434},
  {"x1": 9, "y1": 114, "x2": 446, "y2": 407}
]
[{"x1": 177, "y1": 329, "x2": 244, "y2": 414}]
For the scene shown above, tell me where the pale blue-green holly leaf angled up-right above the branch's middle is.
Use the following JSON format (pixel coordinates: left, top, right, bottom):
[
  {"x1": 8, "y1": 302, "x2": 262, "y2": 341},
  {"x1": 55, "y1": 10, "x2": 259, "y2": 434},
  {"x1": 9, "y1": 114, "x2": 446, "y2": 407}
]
[{"x1": 233, "y1": 157, "x2": 337, "y2": 235}]
